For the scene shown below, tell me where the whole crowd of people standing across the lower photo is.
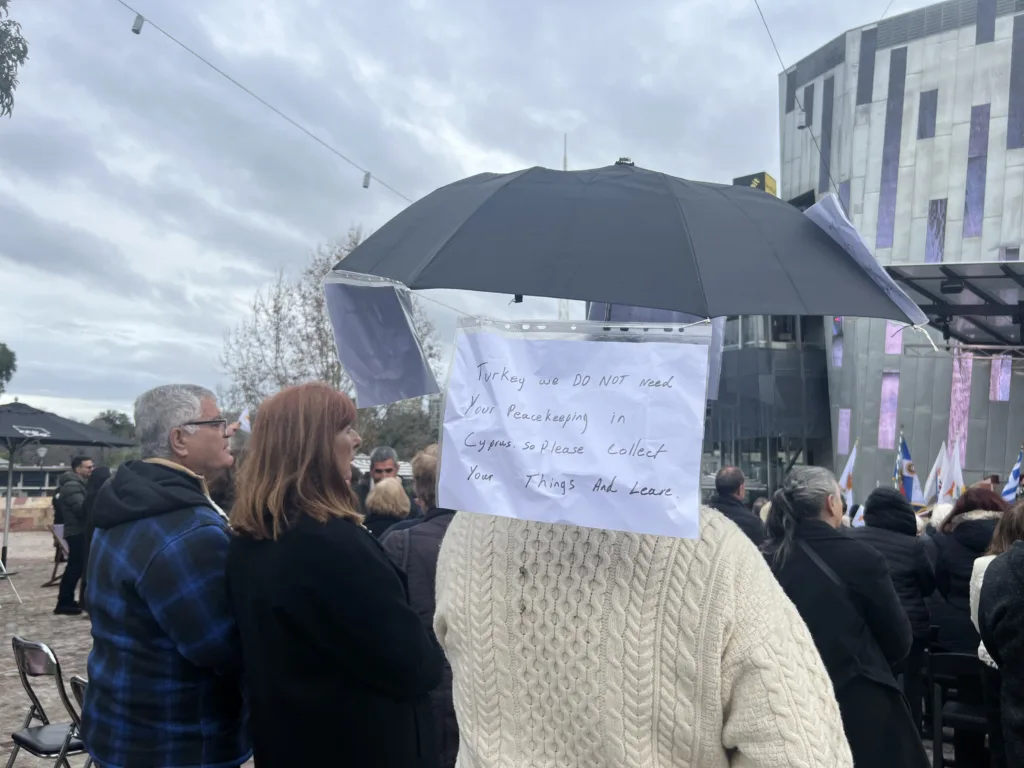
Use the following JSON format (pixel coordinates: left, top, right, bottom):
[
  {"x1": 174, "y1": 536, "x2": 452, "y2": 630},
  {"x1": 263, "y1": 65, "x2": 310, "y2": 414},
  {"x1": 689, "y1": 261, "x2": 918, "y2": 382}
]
[{"x1": 44, "y1": 383, "x2": 1024, "y2": 768}]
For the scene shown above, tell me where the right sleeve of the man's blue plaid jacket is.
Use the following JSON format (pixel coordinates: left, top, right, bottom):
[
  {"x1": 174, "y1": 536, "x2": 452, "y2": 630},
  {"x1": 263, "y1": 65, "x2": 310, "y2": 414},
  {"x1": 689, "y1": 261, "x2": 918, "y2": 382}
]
[{"x1": 136, "y1": 520, "x2": 242, "y2": 674}]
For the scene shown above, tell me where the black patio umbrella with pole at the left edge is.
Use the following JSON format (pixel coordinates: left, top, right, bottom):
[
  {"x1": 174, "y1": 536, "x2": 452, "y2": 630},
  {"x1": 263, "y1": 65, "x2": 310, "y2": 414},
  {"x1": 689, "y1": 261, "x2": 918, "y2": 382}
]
[{"x1": 0, "y1": 402, "x2": 134, "y2": 568}]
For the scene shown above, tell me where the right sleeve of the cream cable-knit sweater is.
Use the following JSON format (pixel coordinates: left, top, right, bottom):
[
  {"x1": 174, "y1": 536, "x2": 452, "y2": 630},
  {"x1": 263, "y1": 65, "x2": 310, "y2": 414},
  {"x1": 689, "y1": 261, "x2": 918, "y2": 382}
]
[{"x1": 719, "y1": 528, "x2": 853, "y2": 768}]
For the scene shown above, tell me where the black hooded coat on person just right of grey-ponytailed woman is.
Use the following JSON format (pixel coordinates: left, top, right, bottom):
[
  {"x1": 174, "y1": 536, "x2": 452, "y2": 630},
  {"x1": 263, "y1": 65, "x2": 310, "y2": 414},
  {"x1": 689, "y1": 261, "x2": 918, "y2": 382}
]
[{"x1": 850, "y1": 505, "x2": 935, "y2": 640}]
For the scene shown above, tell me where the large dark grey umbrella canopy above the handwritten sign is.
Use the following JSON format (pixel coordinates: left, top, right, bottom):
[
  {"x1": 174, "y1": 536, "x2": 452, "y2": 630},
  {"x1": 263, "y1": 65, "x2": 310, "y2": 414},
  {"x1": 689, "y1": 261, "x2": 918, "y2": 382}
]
[{"x1": 338, "y1": 164, "x2": 924, "y2": 324}]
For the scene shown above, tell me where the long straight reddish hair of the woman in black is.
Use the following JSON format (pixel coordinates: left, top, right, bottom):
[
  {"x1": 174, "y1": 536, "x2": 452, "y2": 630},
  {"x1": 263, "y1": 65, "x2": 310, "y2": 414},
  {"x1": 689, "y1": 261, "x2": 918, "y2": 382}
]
[{"x1": 231, "y1": 383, "x2": 362, "y2": 540}]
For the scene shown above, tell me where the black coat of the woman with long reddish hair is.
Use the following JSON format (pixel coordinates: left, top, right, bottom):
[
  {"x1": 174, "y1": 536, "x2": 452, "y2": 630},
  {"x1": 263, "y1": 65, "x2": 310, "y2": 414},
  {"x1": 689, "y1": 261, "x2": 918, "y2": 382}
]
[{"x1": 227, "y1": 515, "x2": 444, "y2": 768}]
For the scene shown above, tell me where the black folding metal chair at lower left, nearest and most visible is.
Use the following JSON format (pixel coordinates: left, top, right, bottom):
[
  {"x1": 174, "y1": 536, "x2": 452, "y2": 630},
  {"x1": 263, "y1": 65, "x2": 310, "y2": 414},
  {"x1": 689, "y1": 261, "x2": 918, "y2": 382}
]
[{"x1": 7, "y1": 637, "x2": 92, "y2": 768}]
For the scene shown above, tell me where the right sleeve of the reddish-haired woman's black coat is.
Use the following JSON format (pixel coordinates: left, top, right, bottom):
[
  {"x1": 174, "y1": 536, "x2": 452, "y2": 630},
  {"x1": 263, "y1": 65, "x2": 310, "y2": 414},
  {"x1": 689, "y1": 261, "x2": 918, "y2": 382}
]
[{"x1": 297, "y1": 522, "x2": 444, "y2": 696}]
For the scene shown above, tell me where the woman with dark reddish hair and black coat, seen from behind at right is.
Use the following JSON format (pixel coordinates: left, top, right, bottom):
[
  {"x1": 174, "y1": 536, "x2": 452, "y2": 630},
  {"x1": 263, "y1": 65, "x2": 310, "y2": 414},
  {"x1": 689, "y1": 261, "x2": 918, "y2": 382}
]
[{"x1": 929, "y1": 488, "x2": 1007, "y2": 654}]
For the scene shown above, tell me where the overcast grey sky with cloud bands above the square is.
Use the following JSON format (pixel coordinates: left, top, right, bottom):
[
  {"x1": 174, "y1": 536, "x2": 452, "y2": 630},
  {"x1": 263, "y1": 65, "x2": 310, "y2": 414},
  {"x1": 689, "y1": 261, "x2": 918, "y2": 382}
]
[{"x1": 0, "y1": 0, "x2": 924, "y2": 419}]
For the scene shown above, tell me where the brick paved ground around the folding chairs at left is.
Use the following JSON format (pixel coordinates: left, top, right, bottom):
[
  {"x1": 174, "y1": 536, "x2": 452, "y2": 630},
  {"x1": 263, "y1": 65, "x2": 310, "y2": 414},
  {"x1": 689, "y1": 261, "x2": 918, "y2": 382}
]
[{"x1": 0, "y1": 532, "x2": 952, "y2": 768}]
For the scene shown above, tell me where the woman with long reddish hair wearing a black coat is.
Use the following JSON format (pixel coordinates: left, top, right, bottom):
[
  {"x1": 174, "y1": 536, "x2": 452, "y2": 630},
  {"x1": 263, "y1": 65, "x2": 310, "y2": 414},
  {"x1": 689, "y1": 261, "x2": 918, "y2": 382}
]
[{"x1": 227, "y1": 384, "x2": 443, "y2": 768}]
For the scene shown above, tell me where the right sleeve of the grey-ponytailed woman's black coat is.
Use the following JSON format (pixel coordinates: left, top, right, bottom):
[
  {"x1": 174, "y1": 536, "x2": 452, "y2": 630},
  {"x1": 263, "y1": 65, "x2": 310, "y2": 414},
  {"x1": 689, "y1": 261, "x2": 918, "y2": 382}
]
[{"x1": 849, "y1": 545, "x2": 913, "y2": 665}]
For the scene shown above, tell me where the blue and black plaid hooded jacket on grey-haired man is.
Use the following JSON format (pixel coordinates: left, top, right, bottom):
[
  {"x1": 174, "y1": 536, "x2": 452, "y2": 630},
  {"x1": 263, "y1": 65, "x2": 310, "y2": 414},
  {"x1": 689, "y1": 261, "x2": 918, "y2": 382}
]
[{"x1": 82, "y1": 461, "x2": 251, "y2": 768}]
